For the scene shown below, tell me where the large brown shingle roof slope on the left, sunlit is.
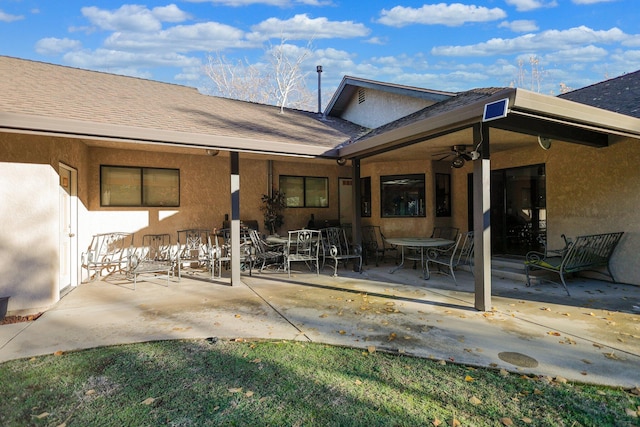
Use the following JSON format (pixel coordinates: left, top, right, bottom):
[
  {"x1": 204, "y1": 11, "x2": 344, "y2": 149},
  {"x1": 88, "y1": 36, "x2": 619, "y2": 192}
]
[{"x1": 0, "y1": 56, "x2": 364, "y2": 147}]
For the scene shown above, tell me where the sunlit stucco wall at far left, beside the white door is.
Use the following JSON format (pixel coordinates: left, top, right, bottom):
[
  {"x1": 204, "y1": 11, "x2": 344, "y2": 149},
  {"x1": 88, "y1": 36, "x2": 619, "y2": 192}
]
[{"x1": 0, "y1": 133, "x2": 86, "y2": 313}]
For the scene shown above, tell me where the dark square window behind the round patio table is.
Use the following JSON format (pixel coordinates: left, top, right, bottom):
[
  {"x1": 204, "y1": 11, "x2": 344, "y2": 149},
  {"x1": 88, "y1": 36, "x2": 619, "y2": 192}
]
[{"x1": 380, "y1": 174, "x2": 425, "y2": 218}]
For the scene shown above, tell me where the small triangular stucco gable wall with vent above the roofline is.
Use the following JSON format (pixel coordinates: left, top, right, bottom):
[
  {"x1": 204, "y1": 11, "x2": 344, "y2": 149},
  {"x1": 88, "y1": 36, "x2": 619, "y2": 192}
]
[{"x1": 340, "y1": 89, "x2": 433, "y2": 129}]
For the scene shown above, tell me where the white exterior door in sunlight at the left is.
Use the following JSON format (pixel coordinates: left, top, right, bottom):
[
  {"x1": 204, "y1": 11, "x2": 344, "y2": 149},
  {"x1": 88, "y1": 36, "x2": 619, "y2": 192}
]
[{"x1": 58, "y1": 164, "x2": 78, "y2": 292}]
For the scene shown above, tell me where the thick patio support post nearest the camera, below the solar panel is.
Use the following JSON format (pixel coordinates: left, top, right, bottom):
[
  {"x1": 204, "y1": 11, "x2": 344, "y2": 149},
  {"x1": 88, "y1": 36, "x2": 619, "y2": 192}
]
[{"x1": 473, "y1": 123, "x2": 491, "y2": 311}]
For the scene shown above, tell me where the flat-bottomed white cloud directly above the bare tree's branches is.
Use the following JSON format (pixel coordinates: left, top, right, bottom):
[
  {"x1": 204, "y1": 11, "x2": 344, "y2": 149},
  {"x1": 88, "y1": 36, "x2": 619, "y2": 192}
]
[{"x1": 247, "y1": 14, "x2": 370, "y2": 41}]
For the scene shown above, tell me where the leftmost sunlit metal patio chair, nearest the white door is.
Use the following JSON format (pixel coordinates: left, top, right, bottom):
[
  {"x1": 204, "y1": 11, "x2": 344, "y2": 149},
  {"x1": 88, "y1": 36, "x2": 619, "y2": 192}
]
[{"x1": 80, "y1": 232, "x2": 133, "y2": 281}]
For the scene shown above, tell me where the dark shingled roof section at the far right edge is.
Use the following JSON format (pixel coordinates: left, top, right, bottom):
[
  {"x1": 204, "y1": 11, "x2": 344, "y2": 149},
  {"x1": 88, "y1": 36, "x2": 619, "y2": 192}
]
[{"x1": 558, "y1": 70, "x2": 640, "y2": 118}]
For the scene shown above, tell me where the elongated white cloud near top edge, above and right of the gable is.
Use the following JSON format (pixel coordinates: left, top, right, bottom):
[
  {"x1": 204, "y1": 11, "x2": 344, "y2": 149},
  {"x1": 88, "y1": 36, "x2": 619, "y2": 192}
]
[{"x1": 377, "y1": 3, "x2": 507, "y2": 27}]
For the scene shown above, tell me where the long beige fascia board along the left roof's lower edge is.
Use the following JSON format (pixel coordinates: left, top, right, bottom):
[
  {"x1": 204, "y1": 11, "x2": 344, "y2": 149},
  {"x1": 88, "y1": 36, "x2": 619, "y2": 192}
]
[{"x1": 0, "y1": 112, "x2": 336, "y2": 157}]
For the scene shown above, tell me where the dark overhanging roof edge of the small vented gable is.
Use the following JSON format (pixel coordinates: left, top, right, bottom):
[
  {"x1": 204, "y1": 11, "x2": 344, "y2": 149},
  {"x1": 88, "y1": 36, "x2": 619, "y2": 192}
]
[{"x1": 325, "y1": 76, "x2": 456, "y2": 117}]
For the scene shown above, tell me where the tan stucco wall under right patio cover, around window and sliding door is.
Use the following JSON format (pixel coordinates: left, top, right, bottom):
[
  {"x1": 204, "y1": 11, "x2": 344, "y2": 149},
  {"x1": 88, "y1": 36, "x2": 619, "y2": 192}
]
[{"x1": 361, "y1": 140, "x2": 640, "y2": 285}]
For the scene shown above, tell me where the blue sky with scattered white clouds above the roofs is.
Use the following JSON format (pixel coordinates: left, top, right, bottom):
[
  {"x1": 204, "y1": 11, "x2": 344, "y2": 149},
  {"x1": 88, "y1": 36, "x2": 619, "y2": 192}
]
[{"x1": 0, "y1": 0, "x2": 640, "y2": 99}]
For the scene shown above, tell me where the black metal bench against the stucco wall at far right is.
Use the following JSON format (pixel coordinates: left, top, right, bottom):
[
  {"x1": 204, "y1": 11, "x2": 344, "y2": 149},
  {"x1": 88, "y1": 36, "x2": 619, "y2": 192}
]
[{"x1": 524, "y1": 231, "x2": 624, "y2": 295}]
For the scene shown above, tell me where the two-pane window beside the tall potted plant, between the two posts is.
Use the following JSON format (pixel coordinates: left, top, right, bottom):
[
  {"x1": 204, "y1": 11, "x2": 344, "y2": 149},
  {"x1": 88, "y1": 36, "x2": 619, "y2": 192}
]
[{"x1": 280, "y1": 176, "x2": 329, "y2": 208}]
